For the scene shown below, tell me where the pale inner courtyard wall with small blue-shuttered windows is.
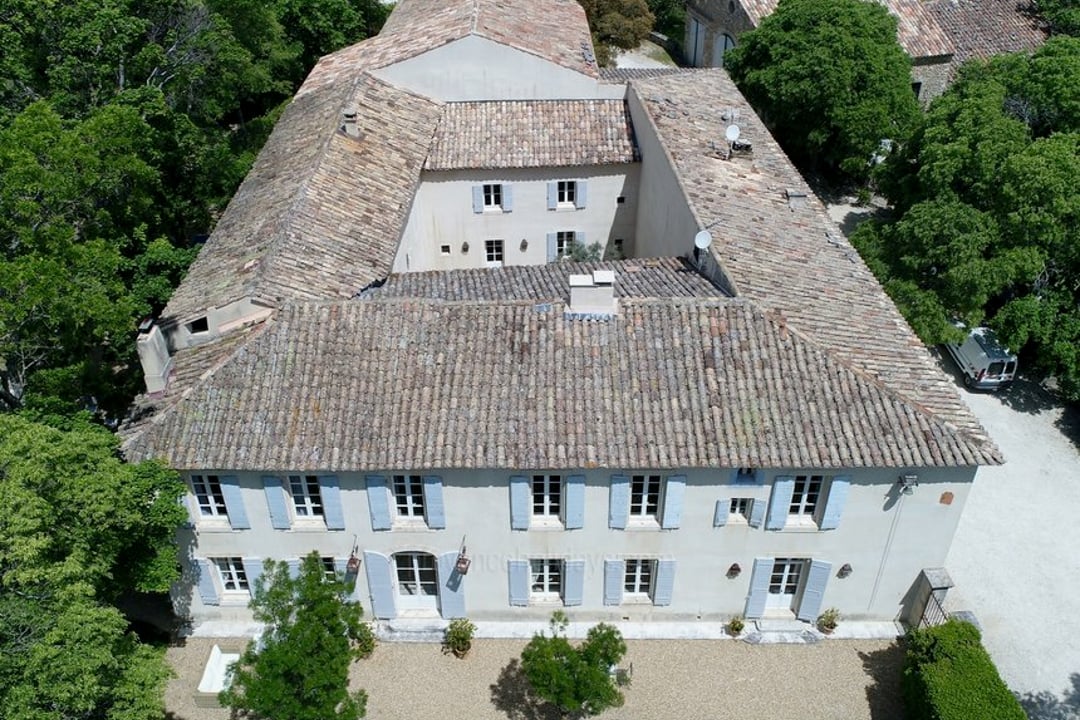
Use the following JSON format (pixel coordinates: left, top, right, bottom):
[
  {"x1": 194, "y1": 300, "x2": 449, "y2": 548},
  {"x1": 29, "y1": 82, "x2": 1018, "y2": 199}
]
[{"x1": 393, "y1": 163, "x2": 640, "y2": 272}]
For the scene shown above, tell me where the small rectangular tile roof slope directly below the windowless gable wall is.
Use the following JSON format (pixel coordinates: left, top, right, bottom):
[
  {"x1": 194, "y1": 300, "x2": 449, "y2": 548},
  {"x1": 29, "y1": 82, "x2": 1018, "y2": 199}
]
[{"x1": 424, "y1": 99, "x2": 636, "y2": 169}]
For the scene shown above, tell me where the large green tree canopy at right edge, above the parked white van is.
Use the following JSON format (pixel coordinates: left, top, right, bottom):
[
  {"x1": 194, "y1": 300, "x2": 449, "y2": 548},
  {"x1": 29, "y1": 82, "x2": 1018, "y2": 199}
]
[{"x1": 852, "y1": 37, "x2": 1080, "y2": 398}]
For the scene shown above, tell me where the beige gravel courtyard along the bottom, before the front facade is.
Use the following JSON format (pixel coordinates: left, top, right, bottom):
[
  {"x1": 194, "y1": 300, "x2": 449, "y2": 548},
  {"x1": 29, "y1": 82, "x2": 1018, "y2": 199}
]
[{"x1": 165, "y1": 638, "x2": 903, "y2": 720}]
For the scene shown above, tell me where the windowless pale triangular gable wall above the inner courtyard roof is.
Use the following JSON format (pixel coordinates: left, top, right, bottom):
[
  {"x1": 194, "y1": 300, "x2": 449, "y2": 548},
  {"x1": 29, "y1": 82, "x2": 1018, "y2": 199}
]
[{"x1": 375, "y1": 36, "x2": 624, "y2": 101}]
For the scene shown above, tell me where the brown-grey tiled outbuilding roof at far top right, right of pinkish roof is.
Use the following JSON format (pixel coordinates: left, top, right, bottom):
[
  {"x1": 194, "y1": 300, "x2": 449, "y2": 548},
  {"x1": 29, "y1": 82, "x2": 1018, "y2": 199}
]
[{"x1": 927, "y1": 0, "x2": 1047, "y2": 72}]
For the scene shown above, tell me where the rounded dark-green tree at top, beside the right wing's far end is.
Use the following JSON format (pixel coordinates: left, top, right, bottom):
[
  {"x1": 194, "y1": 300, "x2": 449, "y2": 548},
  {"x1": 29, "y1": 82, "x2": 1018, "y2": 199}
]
[{"x1": 725, "y1": 0, "x2": 919, "y2": 180}]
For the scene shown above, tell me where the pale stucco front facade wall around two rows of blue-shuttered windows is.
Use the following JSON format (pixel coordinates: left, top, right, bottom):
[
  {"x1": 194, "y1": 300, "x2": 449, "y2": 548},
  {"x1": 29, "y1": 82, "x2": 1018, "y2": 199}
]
[{"x1": 175, "y1": 467, "x2": 974, "y2": 622}]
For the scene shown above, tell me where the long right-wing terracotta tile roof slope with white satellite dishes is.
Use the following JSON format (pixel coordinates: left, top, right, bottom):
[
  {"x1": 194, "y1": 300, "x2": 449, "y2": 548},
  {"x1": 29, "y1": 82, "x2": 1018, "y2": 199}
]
[{"x1": 631, "y1": 70, "x2": 1001, "y2": 465}]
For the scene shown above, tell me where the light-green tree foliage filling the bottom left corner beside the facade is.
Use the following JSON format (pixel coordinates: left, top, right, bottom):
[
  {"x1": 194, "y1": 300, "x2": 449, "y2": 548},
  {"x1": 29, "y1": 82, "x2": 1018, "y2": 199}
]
[{"x1": 0, "y1": 415, "x2": 186, "y2": 720}]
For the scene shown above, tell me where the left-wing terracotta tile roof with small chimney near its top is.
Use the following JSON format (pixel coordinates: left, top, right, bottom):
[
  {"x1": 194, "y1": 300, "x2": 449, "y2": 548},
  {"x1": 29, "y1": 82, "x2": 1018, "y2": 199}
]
[{"x1": 163, "y1": 74, "x2": 442, "y2": 320}]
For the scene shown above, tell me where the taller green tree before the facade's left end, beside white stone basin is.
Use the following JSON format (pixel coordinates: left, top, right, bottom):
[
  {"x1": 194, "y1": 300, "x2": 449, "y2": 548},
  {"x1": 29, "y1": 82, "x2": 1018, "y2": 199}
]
[{"x1": 221, "y1": 552, "x2": 367, "y2": 720}]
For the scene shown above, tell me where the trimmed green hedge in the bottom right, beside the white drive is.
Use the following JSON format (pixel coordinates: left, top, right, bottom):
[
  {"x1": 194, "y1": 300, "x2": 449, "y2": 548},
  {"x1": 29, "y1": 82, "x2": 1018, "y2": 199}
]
[{"x1": 902, "y1": 620, "x2": 1027, "y2": 720}]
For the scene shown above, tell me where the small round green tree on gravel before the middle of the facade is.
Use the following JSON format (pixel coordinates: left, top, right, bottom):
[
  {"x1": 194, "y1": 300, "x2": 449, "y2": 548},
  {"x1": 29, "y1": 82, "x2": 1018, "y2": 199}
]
[{"x1": 522, "y1": 612, "x2": 626, "y2": 717}]
